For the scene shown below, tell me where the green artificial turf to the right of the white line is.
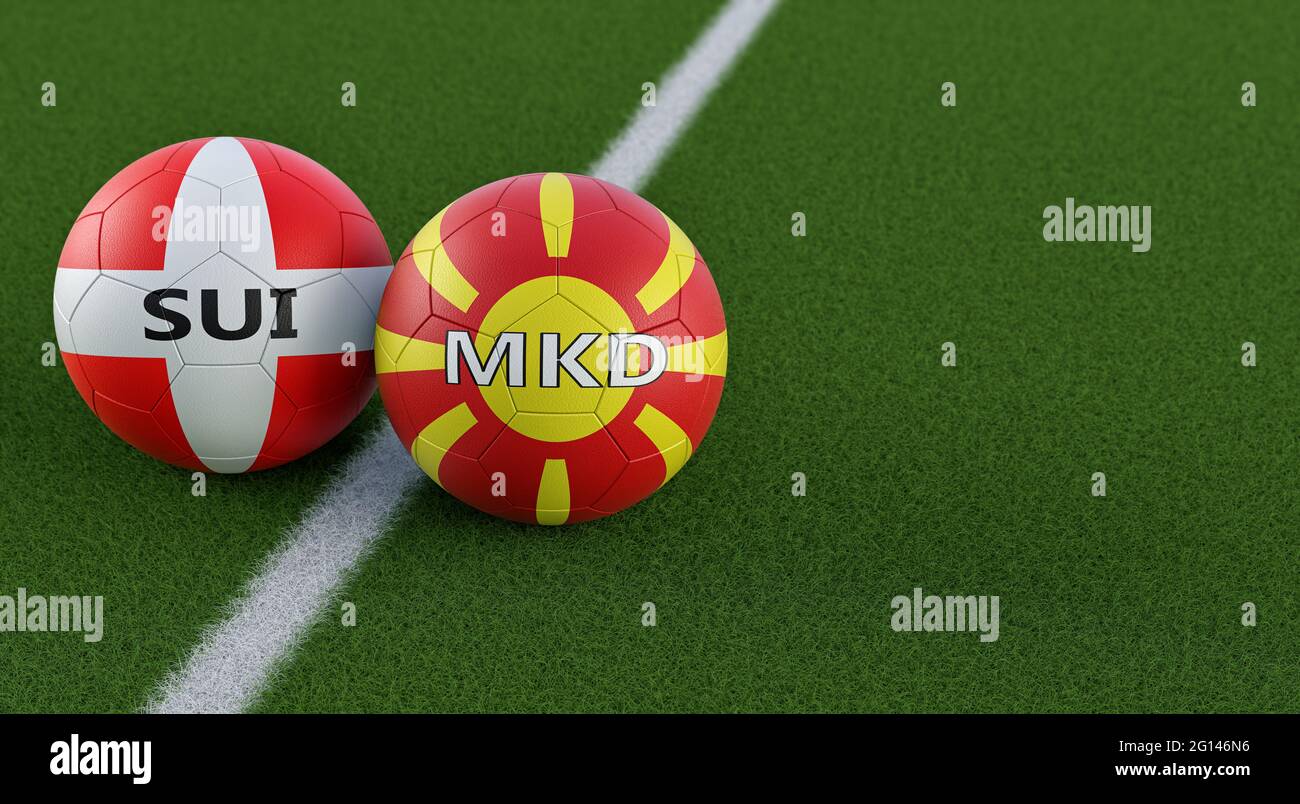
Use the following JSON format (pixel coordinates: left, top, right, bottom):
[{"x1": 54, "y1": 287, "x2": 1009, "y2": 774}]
[{"x1": 260, "y1": 3, "x2": 1300, "y2": 712}]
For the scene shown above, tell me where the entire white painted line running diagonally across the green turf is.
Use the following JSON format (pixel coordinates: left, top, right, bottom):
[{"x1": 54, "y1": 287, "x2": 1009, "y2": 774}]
[{"x1": 146, "y1": 0, "x2": 777, "y2": 713}]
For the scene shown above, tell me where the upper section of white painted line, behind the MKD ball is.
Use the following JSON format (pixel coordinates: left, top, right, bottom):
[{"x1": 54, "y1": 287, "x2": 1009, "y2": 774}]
[{"x1": 592, "y1": 0, "x2": 777, "y2": 190}]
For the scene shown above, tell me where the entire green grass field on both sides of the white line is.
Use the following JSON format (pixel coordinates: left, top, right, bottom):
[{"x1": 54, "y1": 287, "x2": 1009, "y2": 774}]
[{"x1": 0, "y1": 0, "x2": 1300, "y2": 712}]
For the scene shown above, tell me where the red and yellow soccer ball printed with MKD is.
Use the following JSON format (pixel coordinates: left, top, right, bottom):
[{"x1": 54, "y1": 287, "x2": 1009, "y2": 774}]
[{"x1": 374, "y1": 173, "x2": 727, "y2": 524}]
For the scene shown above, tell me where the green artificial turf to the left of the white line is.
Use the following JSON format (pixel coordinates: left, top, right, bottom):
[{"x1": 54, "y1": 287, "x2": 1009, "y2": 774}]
[{"x1": 0, "y1": 1, "x2": 714, "y2": 712}]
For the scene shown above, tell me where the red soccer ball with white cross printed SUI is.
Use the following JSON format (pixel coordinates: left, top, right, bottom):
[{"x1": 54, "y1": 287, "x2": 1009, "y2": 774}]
[{"x1": 55, "y1": 137, "x2": 393, "y2": 472}]
